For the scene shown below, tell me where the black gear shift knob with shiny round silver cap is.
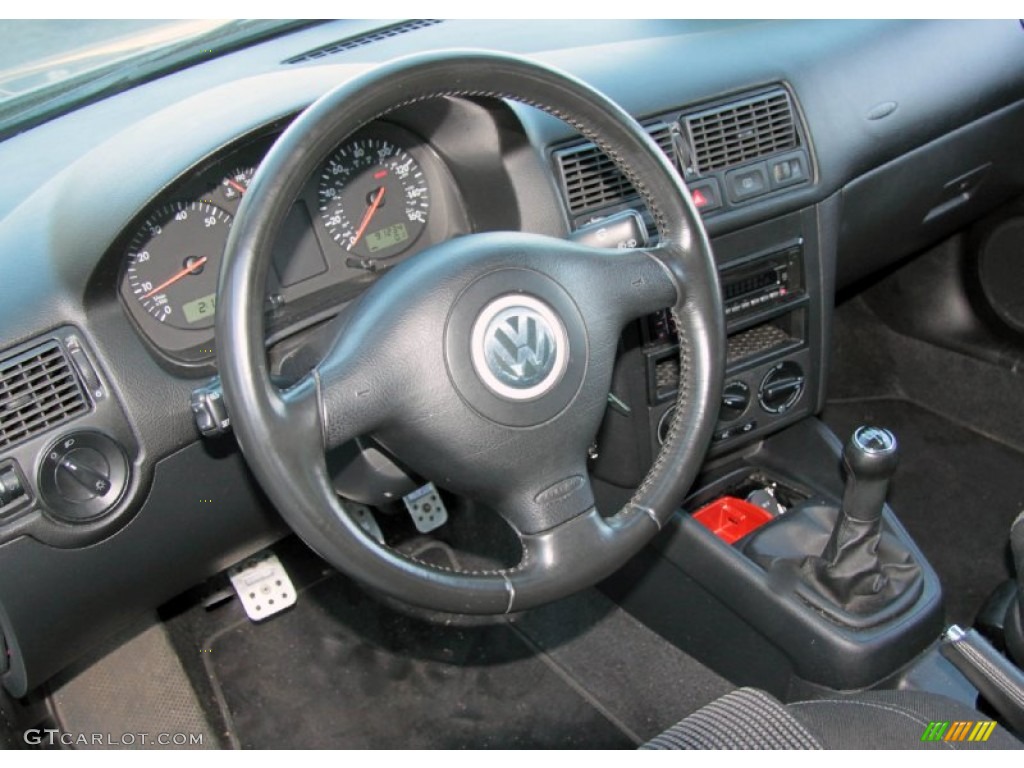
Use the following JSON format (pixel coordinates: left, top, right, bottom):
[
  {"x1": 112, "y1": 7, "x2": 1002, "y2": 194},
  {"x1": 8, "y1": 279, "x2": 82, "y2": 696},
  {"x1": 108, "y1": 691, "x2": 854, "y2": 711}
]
[{"x1": 843, "y1": 427, "x2": 899, "y2": 522}]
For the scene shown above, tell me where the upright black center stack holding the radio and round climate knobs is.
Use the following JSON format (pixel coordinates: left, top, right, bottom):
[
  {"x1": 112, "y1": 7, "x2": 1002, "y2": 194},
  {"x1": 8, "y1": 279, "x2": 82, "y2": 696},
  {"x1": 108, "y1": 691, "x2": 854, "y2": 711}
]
[{"x1": 592, "y1": 208, "x2": 833, "y2": 488}]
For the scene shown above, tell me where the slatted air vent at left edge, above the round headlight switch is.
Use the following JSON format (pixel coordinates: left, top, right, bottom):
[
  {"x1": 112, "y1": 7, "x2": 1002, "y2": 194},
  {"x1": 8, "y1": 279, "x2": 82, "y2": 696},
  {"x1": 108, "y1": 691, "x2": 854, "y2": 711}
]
[{"x1": 0, "y1": 341, "x2": 88, "y2": 449}]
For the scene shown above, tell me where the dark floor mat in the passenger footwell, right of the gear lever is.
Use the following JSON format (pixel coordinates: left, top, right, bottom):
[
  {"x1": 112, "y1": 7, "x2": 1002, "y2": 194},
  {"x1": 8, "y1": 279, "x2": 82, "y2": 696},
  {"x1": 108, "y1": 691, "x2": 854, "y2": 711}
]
[{"x1": 823, "y1": 399, "x2": 1024, "y2": 626}]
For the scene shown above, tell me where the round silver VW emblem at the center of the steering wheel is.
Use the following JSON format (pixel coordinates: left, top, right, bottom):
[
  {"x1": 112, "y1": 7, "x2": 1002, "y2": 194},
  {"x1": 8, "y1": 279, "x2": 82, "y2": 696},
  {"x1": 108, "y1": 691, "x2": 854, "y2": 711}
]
[{"x1": 471, "y1": 295, "x2": 568, "y2": 400}]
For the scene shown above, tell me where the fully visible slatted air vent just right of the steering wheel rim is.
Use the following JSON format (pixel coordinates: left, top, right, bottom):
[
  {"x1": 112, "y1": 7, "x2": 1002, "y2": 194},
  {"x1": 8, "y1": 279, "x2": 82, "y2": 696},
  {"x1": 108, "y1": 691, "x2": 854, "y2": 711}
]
[{"x1": 683, "y1": 89, "x2": 800, "y2": 175}]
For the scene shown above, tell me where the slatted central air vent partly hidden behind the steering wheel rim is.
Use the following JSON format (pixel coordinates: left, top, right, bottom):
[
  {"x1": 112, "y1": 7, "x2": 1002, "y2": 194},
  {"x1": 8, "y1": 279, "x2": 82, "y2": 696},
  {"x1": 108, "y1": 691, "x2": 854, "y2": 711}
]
[{"x1": 556, "y1": 123, "x2": 674, "y2": 215}]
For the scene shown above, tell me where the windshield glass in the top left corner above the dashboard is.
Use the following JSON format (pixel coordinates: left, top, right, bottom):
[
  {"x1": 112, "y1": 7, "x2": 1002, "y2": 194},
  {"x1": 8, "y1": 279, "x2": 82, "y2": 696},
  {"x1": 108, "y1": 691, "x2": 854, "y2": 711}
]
[{"x1": 0, "y1": 18, "x2": 307, "y2": 138}]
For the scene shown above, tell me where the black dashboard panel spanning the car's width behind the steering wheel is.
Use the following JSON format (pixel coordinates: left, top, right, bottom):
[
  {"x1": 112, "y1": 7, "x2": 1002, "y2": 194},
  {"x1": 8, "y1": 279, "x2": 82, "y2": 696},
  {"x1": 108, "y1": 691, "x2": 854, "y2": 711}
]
[{"x1": 0, "y1": 19, "x2": 1024, "y2": 692}]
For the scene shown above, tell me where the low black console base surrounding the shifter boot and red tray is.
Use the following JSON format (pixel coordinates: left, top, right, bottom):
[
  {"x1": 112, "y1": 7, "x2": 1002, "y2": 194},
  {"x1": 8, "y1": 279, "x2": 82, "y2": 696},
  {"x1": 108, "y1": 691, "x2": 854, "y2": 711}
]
[{"x1": 605, "y1": 418, "x2": 943, "y2": 698}]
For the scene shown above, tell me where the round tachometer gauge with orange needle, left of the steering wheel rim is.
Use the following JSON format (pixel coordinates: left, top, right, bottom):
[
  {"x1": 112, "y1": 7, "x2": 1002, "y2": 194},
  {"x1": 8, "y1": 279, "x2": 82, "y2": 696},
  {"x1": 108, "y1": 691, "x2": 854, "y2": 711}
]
[{"x1": 125, "y1": 202, "x2": 231, "y2": 330}]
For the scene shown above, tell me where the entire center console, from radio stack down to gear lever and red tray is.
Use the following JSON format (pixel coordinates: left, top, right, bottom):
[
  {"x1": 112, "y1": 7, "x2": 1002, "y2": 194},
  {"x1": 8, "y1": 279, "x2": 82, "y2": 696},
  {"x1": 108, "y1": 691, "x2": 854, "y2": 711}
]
[{"x1": 592, "y1": 201, "x2": 963, "y2": 699}]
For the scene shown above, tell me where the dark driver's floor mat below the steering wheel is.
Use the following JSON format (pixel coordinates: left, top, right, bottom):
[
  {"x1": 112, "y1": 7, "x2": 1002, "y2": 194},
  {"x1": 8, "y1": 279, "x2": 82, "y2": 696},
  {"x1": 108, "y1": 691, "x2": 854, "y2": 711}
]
[{"x1": 209, "y1": 578, "x2": 632, "y2": 749}]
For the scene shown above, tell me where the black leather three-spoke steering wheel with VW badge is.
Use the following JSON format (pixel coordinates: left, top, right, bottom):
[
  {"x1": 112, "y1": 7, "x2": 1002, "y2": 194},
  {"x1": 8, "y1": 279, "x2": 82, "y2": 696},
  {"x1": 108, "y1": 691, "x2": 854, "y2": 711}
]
[{"x1": 216, "y1": 51, "x2": 725, "y2": 613}]
